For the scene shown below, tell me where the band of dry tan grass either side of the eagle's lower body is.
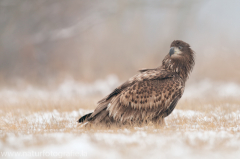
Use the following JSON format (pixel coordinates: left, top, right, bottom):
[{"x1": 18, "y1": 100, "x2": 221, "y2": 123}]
[{"x1": 0, "y1": 98, "x2": 240, "y2": 134}]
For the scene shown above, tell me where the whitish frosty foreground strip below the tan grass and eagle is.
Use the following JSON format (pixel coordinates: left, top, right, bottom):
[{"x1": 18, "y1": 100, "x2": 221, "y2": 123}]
[{"x1": 4, "y1": 131, "x2": 240, "y2": 159}]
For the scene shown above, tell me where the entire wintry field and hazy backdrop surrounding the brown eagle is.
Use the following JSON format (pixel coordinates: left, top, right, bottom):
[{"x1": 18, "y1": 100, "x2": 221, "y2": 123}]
[{"x1": 0, "y1": 0, "x2": 240, "y2": 159}]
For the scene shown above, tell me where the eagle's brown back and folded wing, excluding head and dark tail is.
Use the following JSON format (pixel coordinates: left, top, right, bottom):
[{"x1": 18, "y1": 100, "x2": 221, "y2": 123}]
[{"x1": 88, "y1": 69, "x2": 184, "y2": 122}]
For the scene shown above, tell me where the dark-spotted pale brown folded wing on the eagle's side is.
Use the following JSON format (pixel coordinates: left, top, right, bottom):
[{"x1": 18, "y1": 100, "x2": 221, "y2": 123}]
[{"x1": 107, "y1": 77, "x2": 184, "y2": 122}]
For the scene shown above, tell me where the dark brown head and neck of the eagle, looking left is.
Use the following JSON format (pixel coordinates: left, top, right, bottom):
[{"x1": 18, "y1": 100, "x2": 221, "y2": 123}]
[{"x1": 162, "y1": 40, "x2": 194, "y2": 79}]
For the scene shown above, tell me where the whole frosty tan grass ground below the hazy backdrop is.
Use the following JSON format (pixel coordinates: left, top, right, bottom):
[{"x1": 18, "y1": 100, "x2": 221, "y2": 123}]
[{"x1": 0, "y1": 75, "x2": 240, "y2": 159}]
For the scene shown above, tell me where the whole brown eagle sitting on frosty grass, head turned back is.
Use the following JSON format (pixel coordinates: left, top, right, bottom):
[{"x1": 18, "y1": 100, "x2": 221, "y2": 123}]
[{"x1": 79, "y1": 40, "x2": 194, "y2": 125}]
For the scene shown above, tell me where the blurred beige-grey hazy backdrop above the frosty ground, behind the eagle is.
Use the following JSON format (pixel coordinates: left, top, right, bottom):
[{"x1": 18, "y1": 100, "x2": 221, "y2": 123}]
[{"x1": 0, "y1": 0, "x2": 240, "y2": 87}]
